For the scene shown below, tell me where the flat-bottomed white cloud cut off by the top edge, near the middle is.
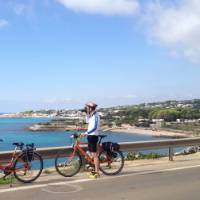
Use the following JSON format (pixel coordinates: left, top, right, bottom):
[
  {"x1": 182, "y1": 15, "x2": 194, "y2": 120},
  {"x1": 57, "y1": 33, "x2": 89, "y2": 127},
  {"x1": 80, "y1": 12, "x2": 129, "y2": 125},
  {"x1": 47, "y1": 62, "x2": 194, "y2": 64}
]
[{"x1": 56, "y1": 0, "x2": 139, "y2": 16}]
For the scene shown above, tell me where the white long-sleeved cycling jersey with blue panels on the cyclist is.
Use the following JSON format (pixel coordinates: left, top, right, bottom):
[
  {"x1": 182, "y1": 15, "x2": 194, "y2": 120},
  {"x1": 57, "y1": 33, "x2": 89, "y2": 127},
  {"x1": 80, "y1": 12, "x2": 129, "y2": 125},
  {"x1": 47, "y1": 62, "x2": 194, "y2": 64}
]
[{"x1": 86, "y1": 112, "x2": 100, "y2": 136}]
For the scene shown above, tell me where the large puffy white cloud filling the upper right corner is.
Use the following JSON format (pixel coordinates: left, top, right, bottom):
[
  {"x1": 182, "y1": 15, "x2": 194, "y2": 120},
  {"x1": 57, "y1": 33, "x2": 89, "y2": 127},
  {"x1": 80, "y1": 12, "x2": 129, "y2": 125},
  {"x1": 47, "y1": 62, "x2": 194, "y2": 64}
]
[{"x1": 140, "y1": 0, "x2": 200, "y2": 63}]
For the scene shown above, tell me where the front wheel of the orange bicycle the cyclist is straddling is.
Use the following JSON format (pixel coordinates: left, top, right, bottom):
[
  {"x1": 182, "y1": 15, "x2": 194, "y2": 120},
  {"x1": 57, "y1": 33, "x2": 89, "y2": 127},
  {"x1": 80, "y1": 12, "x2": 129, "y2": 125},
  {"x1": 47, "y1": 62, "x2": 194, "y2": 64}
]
[{"x1": 55, "y1": 151, "x2": 82, "y2": 177}]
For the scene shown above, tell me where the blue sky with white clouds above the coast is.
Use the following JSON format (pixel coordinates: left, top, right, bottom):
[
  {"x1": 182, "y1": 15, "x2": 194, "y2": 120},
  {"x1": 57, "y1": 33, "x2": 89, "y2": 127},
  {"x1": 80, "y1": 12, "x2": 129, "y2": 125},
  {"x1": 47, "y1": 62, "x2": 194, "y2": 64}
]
[{"x1": 0, "y1": 0, "x2": 200, "y2": 113}]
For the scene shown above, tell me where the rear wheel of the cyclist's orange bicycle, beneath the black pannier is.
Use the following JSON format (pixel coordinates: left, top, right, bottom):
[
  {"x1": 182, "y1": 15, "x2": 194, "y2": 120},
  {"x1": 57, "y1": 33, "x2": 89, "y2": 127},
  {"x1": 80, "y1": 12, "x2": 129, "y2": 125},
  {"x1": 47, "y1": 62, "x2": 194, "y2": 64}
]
[{"x1": 99, "y1": 151, "x2": 124, "y2": 176}]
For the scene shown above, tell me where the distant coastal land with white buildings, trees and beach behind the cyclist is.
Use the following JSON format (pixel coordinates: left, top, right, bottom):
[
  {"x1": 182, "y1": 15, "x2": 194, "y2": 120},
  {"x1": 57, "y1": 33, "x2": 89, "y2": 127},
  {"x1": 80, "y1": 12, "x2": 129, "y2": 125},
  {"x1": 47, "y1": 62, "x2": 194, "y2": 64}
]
[{"x1": 0, "y1": 99, "x2": 200, "y2": 137}]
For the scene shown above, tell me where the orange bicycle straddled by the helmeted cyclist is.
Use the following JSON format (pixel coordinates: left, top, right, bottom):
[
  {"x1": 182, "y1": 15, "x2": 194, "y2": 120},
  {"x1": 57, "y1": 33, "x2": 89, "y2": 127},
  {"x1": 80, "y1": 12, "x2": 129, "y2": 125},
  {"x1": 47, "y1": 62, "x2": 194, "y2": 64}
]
[{"x1": 55, "y1": 134, "x2": 124, "y2": 177}]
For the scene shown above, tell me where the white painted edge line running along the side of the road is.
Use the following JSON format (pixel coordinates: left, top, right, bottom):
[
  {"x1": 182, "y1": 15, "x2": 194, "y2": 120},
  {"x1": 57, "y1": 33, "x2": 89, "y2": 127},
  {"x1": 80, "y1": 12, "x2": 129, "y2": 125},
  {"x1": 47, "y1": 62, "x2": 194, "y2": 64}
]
[{"x1": 0, "y1": 165, "x2": 200, "y2": 193}]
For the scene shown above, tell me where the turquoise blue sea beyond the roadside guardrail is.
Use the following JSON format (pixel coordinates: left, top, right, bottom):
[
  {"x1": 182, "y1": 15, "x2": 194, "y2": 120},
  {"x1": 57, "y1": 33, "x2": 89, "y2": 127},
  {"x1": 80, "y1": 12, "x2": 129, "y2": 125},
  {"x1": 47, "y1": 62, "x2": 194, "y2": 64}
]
[{"x1": 0, "y1": 118, "x2": 178, "y2": 166}]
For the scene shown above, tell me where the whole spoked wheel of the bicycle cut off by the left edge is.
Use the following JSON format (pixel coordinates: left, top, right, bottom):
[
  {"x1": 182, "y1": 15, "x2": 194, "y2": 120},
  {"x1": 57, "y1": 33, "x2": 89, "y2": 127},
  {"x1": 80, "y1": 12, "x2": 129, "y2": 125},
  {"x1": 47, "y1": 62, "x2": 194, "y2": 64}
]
[{"x1": 14, "y1": 152, "x2": 43, "y2": 183}]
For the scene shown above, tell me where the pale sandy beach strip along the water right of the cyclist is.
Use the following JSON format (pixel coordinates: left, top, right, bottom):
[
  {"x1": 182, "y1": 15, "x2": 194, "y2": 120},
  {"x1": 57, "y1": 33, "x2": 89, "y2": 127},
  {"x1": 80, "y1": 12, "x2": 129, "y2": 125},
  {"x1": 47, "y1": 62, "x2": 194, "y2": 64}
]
[{"x1": 109, "y1": 127, "x2": 190, "y2": 138}]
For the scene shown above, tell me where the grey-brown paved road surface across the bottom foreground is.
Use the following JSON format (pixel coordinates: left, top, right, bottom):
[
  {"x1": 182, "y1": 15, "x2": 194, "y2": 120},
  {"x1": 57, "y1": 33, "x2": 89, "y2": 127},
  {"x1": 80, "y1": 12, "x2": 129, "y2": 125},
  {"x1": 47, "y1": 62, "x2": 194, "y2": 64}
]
[{"x1": 0, "y1": 166, "x2": 200, "y2": 200}]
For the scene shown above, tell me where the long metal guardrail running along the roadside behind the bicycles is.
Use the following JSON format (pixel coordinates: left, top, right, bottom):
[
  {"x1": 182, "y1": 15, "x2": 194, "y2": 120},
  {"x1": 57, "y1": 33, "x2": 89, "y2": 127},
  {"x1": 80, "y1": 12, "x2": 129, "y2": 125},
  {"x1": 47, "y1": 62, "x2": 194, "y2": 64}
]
[{"x1": 0, "y1": 137, "x2": 200, "y2": 162}]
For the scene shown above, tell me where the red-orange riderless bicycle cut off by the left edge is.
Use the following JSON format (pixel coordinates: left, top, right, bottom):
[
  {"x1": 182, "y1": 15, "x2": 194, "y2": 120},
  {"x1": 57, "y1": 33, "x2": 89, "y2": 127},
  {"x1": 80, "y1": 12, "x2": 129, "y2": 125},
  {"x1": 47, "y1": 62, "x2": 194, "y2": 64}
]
[{"x1": 0, "y1": 139, "x2": 43, "y2": 183}]
